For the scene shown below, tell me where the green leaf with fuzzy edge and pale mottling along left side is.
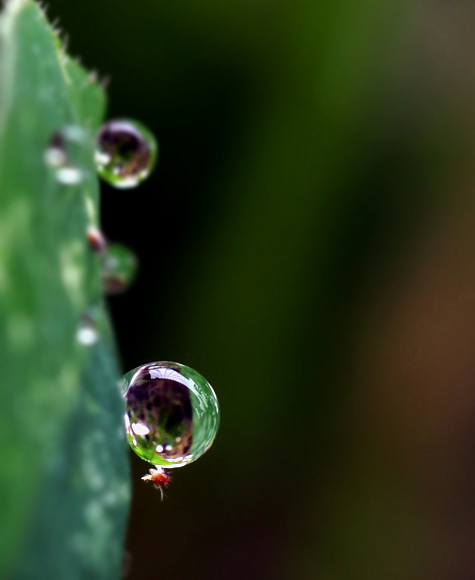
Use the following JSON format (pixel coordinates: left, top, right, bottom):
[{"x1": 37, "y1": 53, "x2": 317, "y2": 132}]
[{"x1": 0, "y1": 0, "x2": 129, "y2": 580}]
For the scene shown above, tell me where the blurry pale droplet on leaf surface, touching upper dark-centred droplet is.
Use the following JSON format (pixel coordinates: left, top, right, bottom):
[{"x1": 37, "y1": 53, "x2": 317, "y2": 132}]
[{"x1": 44, "y1": 125, "x2": 89, "y2": 185}]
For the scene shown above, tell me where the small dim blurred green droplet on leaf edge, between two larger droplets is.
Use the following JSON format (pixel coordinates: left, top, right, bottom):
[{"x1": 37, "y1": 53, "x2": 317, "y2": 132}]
[{"x1": 102, "y1": 244, "x2": 137, "y2": 294}]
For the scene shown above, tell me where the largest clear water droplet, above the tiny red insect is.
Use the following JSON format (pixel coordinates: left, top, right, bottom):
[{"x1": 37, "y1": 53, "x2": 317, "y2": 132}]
[{"x1": 122, "y1": 362, "x2": 219, "y2": 468}]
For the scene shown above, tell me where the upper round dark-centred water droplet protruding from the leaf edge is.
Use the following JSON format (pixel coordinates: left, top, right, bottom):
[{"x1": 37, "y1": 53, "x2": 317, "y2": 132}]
[{"x1": 94, "y1": 119, "x2": 158, "y2": 189}]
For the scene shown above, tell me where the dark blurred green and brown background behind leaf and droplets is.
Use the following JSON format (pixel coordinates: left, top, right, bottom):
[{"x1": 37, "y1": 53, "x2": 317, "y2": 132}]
[{"x1": 48, "y1": 0, "x2": 475, "y2": 580}]
